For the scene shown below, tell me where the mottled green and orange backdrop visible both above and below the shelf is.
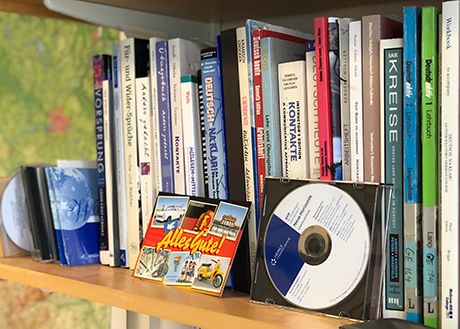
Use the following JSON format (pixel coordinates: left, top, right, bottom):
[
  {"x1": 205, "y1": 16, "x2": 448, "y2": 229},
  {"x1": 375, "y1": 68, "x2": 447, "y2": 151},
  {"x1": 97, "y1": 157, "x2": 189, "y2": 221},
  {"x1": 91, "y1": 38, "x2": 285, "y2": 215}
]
[{"x1": 0, "y1": 12, "x2": 118, "y2": 329}]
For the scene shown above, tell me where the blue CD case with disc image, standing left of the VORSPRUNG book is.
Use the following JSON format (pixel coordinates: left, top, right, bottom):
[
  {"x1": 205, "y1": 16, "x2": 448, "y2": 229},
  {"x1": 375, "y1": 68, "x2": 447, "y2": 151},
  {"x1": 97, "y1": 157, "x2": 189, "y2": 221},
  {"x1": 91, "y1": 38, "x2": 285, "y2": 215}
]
[{"x1": 45, "y1": 167, "x2": 100, "y2": 266}]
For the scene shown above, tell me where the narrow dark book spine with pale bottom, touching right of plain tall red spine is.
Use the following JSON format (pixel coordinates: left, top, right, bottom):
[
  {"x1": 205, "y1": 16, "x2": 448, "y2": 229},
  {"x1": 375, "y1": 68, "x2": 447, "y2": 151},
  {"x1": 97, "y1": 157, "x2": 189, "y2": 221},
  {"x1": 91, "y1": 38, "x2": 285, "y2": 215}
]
[{"x1": 328, "y1": 17, "x2": 343, "y2": 180}]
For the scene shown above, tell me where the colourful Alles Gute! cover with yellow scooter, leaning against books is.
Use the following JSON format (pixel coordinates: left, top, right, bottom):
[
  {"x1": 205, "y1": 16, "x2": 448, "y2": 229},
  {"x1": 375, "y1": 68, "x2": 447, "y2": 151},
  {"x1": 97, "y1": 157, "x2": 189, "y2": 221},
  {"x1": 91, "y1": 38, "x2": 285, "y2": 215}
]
[{"x1": 134, "y1": 192, "x2": 250, "y2": 296}]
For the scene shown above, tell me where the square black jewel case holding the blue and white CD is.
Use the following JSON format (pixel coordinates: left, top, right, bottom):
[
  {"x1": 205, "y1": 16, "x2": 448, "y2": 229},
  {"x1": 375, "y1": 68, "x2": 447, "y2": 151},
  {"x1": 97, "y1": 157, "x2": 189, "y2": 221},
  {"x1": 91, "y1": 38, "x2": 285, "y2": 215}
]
[{"x1": 251, "y1": 178, "x2": 387, "y2": 320}]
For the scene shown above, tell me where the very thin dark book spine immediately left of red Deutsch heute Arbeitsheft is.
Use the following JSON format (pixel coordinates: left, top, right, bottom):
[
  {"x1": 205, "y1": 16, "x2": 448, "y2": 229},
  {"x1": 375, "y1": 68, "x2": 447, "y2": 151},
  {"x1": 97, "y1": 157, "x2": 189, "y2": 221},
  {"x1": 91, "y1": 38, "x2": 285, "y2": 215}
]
[{"x1": 246, "y1": 20, "x2": 263, "y2": 226}]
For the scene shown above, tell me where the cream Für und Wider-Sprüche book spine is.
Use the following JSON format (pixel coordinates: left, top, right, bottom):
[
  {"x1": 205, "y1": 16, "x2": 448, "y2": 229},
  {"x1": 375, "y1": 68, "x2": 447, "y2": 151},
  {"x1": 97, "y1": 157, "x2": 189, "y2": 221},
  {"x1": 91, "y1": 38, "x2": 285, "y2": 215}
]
[{"x1": 120, "y1": 38, "x2": 140, "y2": 268}]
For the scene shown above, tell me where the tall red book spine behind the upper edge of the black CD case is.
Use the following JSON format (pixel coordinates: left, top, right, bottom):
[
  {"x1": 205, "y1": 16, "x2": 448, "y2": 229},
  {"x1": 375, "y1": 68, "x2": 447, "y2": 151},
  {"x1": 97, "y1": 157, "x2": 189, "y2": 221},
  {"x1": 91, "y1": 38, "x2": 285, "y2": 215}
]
[{"x1": 314, "y1": 17, "x2": 334, "y2": 180}]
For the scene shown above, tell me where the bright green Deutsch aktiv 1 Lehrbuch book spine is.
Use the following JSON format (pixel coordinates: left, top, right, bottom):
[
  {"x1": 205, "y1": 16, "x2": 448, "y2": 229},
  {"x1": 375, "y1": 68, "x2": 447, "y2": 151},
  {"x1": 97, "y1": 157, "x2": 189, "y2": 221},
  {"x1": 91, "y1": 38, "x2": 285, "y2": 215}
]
[{"x1": 421, "y1": 7, "x2": 439, "y2": 328}]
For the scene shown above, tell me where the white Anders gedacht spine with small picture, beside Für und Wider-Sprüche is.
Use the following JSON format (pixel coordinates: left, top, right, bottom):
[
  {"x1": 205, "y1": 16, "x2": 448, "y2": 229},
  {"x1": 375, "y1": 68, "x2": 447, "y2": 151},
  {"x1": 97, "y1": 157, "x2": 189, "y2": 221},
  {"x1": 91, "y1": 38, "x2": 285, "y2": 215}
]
[{"x1": 136, "y1": 77, "x2": 155, "y2": 237}]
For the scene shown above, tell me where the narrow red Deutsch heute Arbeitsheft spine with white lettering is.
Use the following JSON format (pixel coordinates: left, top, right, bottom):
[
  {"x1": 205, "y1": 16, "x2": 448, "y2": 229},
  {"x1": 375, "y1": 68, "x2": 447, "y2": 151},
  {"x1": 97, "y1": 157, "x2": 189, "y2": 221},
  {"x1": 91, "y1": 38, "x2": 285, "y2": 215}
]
[{"x1": 252, "y1": 30, "x2": 265, "y2": 204}]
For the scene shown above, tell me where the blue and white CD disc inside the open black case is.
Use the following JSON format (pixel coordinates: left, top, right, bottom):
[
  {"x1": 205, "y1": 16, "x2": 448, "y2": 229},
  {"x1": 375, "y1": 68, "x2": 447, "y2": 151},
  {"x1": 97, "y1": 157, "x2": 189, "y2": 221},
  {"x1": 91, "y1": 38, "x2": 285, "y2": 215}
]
[{"x1": 264, "y1": 183, "x2": 370, "y2": 310}]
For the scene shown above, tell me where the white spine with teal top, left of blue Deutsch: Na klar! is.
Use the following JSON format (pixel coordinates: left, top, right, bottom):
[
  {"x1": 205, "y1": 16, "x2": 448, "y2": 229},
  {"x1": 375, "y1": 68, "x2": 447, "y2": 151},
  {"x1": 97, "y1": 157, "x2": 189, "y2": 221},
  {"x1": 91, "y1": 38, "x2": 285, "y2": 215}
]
[{"x1": 181, "y1": 75, "x2": 205, "y2": 197}]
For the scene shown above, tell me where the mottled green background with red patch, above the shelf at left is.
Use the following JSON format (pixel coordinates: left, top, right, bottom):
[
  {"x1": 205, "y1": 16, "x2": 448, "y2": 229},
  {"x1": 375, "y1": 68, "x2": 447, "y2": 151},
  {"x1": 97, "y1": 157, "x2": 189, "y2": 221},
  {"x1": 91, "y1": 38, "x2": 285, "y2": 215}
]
[{"x1": 0, "y1": 12, "x2": 119, "y2": 176}]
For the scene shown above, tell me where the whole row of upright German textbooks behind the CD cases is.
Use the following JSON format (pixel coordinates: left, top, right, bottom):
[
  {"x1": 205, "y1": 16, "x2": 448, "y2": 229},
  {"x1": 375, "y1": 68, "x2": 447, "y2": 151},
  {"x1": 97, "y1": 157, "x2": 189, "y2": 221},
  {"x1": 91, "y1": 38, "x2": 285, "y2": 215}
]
[{"x1": 95, "y1": 1, "x2": 460, "y2": 328}]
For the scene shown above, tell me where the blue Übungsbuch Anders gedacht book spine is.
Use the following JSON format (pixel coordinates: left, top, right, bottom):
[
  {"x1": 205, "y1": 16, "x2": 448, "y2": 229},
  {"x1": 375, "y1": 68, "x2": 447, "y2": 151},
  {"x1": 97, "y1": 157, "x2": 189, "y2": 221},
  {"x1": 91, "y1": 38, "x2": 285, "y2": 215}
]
[{"x1": 155, "y1": 41, "x2": 174, "y2": 193}]
